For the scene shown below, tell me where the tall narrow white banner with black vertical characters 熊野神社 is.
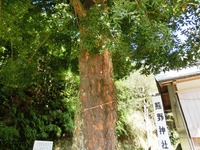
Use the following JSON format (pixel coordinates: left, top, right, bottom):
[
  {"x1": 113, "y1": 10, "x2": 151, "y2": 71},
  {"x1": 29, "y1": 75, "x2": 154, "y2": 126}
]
[{"x1": 152, "y1": 95, "x2": 172, "y2": 150}]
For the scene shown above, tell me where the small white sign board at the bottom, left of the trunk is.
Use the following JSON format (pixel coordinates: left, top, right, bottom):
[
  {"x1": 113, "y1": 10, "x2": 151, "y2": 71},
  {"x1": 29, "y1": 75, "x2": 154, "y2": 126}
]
[{"x1": 33, "y1": 140, "x2": 53, "y2": 150}]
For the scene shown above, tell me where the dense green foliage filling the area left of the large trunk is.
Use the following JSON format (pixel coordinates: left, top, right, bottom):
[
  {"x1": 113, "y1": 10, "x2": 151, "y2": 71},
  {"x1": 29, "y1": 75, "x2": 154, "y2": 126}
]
[{"x1": 0, "y1": 1, "x2": 79, "y2": 149}]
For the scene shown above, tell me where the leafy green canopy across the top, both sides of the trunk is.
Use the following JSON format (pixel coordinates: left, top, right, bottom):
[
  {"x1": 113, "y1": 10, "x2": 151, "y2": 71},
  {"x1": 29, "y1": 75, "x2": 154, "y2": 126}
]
[{"x1": 0, "y1": 0, "x2": 199, "y2": 78}]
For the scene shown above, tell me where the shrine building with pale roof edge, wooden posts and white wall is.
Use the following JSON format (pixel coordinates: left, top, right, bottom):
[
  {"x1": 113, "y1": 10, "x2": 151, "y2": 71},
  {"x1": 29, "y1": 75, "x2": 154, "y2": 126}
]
[{"x1": 155, "y1": 66, "x2": 200, "y2": 150}]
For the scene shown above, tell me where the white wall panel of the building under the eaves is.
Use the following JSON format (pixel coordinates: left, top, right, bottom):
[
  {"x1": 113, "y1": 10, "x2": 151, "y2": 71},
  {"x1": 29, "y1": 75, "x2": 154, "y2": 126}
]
[{"x1": 177, "y1": 80, "x2": 200, "y2": 138}]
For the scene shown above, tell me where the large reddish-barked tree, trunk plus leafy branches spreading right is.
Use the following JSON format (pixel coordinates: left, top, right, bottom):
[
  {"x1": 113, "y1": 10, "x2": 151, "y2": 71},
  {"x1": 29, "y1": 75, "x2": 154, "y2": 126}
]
[{"x1": 71, "y1": 0, "x2": 199, "y2": 149}]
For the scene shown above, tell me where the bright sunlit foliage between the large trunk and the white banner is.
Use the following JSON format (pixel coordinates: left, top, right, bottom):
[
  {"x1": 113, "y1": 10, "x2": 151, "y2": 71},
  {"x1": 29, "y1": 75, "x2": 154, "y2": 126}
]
[{"x1": 116, "y1": 71, "x2": 157, "y2": 149}]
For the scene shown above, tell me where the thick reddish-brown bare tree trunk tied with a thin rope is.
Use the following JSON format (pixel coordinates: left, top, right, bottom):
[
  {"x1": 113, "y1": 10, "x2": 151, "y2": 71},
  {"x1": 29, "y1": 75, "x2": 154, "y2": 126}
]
[{"x1": 72, "y1": 51, "x2": 117, "y2": 150}]
